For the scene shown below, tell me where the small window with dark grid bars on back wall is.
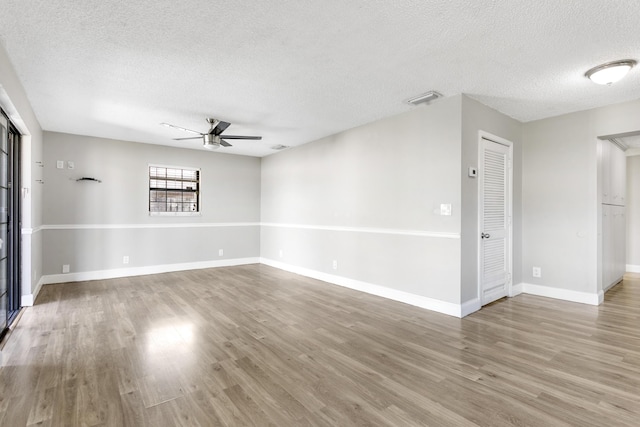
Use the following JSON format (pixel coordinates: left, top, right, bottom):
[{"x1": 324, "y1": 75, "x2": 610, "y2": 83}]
[{"x1": 149, "y1": 165, "x2": 200, "y2": 215}]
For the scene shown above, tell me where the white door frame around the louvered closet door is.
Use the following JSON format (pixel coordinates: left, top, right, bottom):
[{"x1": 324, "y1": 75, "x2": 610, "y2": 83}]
[{"x1": 476, "y1": 130, "x2": 515, "y2": 307}]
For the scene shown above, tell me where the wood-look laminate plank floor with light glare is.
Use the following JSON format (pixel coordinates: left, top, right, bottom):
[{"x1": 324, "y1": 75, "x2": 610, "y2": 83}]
[{"x1": 0, "y1": 265, "x2": 640, "y2": 427}]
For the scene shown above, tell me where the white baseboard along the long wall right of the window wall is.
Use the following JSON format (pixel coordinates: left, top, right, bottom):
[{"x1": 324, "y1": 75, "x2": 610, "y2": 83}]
[{"x1": 260, "y1": 258, "x2": 470, "y2": 317}]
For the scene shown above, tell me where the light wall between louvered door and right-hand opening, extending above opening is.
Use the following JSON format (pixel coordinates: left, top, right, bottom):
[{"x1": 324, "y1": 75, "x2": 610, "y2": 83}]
[{"x1": 522, "y1": 101, "x2": 640, "y2": 303}]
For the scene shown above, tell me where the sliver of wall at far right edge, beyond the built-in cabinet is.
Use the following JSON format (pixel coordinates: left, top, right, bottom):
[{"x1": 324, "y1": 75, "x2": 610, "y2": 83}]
[{"x1": 626, "y1": 155, "x2": 640, "y2": 273}]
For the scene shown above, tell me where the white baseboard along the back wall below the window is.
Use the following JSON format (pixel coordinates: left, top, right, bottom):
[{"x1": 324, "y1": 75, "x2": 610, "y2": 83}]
[{"x1": 41, "y1": 257, "x2": 260, "y2": 285}]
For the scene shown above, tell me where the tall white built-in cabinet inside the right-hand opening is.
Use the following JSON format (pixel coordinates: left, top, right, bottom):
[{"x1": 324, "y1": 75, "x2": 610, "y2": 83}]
[{"x1": 600, "y1": 140, "x2": 627, "y2": 289}]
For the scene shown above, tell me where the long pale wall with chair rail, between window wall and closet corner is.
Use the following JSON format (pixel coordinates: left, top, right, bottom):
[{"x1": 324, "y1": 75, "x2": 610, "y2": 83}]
[{"x1": 261, "y1": 96, "x2": 461, "y2": 312}]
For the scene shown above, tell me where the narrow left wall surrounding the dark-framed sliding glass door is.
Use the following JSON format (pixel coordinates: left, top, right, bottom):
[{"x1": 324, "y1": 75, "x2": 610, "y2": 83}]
[{"x1": 0, "y1": 43, "x2": 42, "y2": 305}]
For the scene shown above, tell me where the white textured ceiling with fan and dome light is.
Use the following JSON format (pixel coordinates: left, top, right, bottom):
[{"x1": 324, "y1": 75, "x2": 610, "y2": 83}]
[{"x1": 0, "y1": 0, "x2": 640, "y2": 156}]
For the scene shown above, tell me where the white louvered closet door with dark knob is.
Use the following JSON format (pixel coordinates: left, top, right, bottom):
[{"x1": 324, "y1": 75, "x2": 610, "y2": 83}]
[{"x1": 479, "y1": 137, "x2": 512, "y2": 305}]
